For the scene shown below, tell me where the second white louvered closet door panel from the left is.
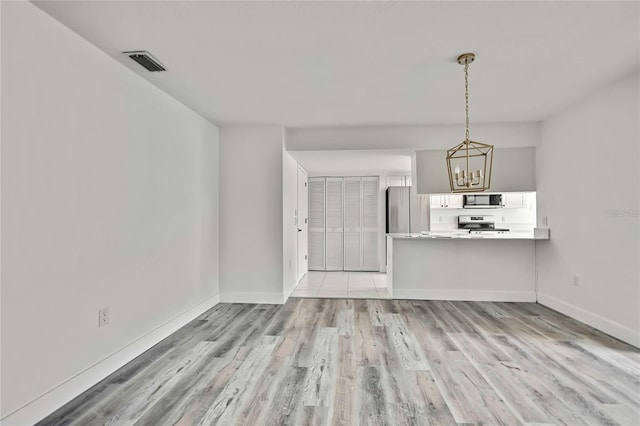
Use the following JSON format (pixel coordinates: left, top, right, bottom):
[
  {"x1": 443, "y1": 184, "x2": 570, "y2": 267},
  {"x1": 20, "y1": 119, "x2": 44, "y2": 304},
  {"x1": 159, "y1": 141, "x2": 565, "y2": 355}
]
[{"x1": 325, "y1": 178, "x2": 344, "y2": 271}]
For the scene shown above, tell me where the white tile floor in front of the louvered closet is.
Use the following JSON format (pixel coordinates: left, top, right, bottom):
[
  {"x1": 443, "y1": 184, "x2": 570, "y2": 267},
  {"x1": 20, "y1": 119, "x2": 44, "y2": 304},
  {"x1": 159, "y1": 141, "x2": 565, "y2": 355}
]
[{"x1": 291, "y1": 271, "x2": 391, "y2": 299}]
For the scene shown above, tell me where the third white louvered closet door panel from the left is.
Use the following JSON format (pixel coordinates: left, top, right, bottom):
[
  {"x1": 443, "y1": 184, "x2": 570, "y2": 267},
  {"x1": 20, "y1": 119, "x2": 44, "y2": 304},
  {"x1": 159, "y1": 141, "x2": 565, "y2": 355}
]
[{"x1": 344, "y1": 177, "x2": 362, "y2": 271}]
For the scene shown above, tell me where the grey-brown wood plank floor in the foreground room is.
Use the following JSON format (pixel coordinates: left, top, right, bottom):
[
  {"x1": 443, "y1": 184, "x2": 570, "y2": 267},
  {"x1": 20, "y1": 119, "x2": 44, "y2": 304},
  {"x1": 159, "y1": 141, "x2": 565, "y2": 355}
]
[{"x1": 39, "y1": 298, "x2": 640, "y2": 426}]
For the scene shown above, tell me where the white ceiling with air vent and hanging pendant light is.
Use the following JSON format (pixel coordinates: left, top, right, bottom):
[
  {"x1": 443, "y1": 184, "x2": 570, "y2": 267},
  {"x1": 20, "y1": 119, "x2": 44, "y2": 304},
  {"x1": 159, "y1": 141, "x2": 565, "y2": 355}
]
[{"x1": 35, "y1": 1, "x2": 640, "y2": 127}]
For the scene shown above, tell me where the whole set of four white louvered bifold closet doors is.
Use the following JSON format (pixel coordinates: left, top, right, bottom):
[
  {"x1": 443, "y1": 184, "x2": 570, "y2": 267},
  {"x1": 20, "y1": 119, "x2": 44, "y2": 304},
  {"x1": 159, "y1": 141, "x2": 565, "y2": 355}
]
[{"x1": 309, "y1": 176, "x2": 380, "y2": 271}]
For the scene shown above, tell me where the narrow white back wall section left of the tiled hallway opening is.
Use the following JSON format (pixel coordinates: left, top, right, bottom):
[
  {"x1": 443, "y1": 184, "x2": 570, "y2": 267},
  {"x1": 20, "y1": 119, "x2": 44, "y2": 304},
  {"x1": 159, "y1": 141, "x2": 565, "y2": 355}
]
[{"x1": 220, "y1": 126, "x2": 284, "y2": 303}]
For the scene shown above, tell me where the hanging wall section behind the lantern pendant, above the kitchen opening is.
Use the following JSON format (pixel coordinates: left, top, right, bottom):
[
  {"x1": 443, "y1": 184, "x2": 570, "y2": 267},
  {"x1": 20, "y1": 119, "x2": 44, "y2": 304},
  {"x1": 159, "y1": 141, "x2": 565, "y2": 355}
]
[{"x1": 416, "y1": 146, "x2": 536, "y2": 194}]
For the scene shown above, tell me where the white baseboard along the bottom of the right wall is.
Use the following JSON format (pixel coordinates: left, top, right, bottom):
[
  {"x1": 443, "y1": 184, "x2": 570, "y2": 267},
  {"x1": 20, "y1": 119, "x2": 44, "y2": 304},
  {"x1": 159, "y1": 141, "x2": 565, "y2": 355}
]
[{"x1": 538, "y1": 294, "x2": 640, "y2": 348}]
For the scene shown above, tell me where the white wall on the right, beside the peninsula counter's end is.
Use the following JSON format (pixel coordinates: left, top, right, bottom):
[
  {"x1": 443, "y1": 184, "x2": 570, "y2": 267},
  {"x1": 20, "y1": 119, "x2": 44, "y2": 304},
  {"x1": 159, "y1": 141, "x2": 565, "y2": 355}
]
[{"x1": 536, "y1": 73, "x2": 640, "y2": 346}]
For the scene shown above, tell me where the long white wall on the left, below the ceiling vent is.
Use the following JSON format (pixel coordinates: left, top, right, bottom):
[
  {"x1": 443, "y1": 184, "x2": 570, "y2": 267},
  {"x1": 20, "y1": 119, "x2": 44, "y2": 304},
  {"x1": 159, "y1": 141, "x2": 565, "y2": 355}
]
[{"x1": 1, "y1": 2, "x2": 218, "y2": 424}]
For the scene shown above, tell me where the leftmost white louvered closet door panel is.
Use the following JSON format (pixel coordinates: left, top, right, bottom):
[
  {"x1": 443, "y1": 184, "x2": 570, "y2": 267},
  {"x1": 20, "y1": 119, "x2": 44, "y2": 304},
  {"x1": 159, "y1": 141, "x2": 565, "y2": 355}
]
[{"x1": 309, "y1": 178, "x2": 325, "y2": 271}]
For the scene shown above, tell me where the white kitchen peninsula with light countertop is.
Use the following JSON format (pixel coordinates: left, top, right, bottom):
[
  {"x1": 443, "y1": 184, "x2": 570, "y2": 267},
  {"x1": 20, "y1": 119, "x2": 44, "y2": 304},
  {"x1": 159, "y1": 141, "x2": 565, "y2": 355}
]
[{"x1": 387, "y1": 229, "x2": 549, "y2": 302}]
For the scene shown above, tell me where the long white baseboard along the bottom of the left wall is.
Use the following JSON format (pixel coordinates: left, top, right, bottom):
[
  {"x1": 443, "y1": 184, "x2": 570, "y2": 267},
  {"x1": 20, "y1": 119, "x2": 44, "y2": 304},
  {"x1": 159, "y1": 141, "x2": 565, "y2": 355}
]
[{"x1": 0, "y1": 295, "x2": 220, "y2": 426}]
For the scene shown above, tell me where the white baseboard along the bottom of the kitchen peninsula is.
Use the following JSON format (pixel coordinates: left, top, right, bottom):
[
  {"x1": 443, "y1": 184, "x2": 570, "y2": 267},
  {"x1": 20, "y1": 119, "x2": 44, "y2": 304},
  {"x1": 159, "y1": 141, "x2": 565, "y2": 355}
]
[{"x1": 393, "y1": 288, "x2": 536, "y2": 302}]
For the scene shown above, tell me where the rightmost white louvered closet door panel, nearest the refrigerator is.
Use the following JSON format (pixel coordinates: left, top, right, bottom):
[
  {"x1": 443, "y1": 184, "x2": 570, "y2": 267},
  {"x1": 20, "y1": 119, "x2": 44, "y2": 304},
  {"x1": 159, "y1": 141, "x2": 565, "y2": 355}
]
[{"x1": 362, "y1": 177, "x2": 380, "y2": 271}]
